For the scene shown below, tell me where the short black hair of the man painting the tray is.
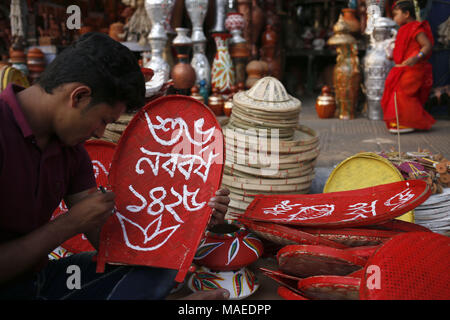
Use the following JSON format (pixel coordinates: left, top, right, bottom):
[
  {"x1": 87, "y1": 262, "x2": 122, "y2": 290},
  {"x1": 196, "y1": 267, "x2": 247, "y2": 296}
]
[{"x1": 38, "y1": 32, "x2": 145, "y2": 112}]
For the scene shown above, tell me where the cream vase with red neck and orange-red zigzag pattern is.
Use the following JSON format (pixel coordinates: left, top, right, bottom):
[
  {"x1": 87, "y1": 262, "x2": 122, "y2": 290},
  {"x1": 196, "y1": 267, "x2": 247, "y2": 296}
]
[{"x1": 211, "y1": 33, "x2": 235, "y2": 95}]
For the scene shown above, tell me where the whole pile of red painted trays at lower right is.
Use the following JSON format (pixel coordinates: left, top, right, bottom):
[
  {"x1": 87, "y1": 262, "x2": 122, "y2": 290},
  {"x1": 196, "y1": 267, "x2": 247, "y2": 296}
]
[{"x1": 238, "y1": 180, "x2": 450, "y2": 300}]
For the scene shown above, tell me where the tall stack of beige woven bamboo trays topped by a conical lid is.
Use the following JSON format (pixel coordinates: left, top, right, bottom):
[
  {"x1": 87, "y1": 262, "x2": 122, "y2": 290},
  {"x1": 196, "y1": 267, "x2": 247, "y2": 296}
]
[{"x1": 222, "y1": 77, "x2": 319, "y2": 219}]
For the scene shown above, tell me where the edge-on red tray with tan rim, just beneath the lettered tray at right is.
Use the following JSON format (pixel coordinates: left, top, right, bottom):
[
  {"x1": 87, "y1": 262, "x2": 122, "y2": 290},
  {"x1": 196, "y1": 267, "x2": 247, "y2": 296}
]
[{"x1": 301, "y1": 228, "x2": 399, "y2": 247}]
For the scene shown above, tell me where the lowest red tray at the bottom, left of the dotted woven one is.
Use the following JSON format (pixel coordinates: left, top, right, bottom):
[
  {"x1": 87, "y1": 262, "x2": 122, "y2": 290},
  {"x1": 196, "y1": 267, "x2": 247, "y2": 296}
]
[{"x1": 297, "y1": 276, "x2": 361, "y2": 300}]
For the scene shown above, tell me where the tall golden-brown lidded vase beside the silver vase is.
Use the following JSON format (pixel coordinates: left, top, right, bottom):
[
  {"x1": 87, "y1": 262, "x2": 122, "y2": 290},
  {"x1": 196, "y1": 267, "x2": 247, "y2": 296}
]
[{"x1": 328, "y1": 15, "x2": 361, "y2": 120}]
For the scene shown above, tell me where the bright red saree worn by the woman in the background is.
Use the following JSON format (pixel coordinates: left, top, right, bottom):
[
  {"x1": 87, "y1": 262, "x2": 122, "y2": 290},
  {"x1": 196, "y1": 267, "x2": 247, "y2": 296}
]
[{"x1": 381, "y1": 21, "x2": 436, "y2": 130}]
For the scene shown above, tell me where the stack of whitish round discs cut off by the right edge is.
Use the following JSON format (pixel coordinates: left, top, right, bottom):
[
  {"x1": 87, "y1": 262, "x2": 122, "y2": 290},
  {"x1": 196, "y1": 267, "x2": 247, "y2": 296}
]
[{"x1": 414, "y1": 188, "x2": 450, "y2": 236}]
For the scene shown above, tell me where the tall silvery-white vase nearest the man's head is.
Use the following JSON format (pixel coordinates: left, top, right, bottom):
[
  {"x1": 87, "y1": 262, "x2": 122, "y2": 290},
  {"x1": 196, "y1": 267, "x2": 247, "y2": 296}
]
[{"x1": 144, "y1": 0, "x2": 175, "y2": 82}]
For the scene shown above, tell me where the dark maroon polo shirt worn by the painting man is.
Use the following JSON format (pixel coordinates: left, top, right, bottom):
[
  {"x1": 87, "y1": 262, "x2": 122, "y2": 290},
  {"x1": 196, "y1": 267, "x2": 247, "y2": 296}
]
[{"x1": 0, "y1": 85, "x2": 96, "y2": 264}]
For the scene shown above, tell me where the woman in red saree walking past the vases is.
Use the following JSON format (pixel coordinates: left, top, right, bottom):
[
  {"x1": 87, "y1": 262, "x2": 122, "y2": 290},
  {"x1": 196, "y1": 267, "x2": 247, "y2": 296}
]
[{"x1": 381, "y1": 0, "x2": 436, "y2": 133}]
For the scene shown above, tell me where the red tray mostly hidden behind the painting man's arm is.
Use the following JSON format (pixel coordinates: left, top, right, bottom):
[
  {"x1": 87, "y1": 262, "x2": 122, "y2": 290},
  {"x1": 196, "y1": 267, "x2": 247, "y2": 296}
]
[{"x1": 53, "y1": 140, "x2": 116, "y2": 253}]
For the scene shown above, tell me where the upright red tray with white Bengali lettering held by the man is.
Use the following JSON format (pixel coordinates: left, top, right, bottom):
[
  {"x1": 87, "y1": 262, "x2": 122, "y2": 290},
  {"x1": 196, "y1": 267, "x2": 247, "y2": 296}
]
[{"x1": 97, "y1": 95, "x2": 224, "y2": 282}]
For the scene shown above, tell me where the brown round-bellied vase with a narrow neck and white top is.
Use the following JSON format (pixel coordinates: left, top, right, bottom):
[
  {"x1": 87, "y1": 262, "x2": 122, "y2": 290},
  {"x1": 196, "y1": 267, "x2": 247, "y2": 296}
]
[{"x1": 171, "y1": 28, "x2": 196, "y2": 95}]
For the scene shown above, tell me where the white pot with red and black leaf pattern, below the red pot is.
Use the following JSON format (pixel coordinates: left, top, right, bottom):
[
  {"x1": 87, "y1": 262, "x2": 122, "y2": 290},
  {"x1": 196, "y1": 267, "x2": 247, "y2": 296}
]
[{"x1": 188, "y1": 267, "x2": 259, "y2": 300}]
